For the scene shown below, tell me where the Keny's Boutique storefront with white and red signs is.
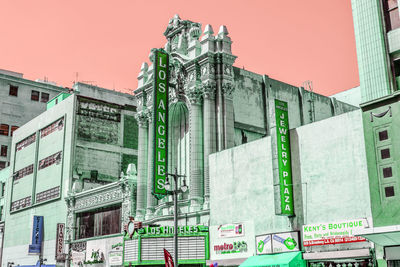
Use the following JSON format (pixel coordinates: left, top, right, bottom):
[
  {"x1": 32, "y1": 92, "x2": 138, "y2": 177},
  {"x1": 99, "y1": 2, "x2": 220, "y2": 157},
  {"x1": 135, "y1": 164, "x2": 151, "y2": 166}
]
[{"x1": 302, "y1": 219, "x2": 373, "y2": 267}]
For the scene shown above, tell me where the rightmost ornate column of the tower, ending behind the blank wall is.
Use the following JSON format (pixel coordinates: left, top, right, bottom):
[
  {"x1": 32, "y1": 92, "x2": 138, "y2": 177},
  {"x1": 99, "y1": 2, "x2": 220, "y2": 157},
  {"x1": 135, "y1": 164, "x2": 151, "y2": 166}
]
[{"x1": 222, "y1": 82, "x2": 235, "y2": 149}]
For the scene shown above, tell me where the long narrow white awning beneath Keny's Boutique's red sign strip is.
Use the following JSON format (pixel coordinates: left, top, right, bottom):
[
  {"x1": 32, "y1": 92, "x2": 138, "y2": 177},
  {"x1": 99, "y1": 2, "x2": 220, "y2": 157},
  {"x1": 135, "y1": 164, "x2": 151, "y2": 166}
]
[{"x1": 303, "y1": 248, "x2": 370, "y2": 260}]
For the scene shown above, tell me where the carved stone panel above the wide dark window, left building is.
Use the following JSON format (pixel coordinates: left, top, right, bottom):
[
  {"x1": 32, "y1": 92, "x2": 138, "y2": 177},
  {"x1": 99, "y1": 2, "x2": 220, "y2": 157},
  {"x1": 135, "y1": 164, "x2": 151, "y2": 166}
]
[{"x1": 75, "y1": 188, "x2": 123, "y2": 211}]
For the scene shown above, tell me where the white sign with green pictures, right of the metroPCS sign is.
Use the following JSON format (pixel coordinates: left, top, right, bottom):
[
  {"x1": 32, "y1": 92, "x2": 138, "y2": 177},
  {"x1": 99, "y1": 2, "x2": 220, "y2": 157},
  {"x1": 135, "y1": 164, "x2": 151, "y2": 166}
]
[{"x1": 256, "y1": 232, "x2": 300, "y2": 255}]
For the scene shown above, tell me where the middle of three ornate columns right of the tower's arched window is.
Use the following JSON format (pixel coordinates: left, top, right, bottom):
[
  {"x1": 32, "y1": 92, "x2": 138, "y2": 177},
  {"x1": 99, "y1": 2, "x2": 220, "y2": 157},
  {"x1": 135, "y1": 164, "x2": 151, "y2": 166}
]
[{"x1": 202, "y1": 81, "x2": 217, "y2": 209}]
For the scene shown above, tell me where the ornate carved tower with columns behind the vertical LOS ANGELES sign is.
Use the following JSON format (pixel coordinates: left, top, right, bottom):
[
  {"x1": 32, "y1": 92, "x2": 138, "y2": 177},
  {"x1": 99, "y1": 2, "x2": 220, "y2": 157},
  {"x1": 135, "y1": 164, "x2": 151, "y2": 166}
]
[{"x1": 135, "y1": 15, "x2": 236, "y2": 220}]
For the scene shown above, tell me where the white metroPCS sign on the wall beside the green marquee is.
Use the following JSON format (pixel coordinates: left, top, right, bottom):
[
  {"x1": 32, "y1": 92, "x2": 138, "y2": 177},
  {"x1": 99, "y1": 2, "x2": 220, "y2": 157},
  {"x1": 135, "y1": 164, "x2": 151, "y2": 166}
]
[{"x1": 210, "y1": 222, "x2": 254, "y2": 260}]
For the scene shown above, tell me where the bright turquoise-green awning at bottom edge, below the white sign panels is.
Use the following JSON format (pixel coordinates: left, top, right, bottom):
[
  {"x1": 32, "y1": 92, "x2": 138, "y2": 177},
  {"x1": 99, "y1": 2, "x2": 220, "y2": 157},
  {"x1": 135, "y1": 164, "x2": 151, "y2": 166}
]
[{"x1": 240, "y1": 252, "x2": 306, "y2": 267}]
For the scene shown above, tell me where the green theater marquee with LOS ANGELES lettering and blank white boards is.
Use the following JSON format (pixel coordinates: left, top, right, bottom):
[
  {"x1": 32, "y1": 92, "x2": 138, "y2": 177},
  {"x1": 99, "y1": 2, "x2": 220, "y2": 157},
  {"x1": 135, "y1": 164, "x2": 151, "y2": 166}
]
[{"x1": 123, "y1": 225, "x2": 209, "y2": 267}]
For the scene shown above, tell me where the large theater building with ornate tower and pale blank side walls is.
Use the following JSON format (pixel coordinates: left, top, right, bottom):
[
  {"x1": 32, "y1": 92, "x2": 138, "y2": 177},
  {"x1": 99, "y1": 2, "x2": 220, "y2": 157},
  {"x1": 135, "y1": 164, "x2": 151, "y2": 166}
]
[{"x1": 124, "y1": 15, "x2": 366, "y2": 266}]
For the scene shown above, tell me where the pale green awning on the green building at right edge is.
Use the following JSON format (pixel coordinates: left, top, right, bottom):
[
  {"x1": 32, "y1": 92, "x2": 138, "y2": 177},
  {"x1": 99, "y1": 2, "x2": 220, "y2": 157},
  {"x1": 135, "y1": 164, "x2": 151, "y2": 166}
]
[{"x1": 353, "y1": 225, "x2": 400, "y2": 247}]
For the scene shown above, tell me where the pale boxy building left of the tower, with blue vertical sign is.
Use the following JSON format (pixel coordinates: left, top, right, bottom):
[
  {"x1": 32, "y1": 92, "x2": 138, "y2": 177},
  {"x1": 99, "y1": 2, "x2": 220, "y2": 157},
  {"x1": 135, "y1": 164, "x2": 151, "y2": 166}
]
[{"x1": 2, "y1": 93, "x2": 137, "y2": 266}]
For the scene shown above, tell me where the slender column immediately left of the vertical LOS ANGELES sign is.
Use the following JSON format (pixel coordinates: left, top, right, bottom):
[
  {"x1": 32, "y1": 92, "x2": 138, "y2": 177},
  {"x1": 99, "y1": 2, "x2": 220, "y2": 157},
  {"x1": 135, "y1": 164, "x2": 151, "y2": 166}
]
[{"x1": 146, "y1": 111, "x2": 156, "y2": 220}]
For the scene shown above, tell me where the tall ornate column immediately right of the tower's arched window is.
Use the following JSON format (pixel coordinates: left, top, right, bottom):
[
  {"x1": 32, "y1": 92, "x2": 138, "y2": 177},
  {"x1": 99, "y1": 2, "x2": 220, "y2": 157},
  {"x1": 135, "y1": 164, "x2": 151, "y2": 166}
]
[{"x1": 186, "y1": 87, "x2": 204, "y2": 211}]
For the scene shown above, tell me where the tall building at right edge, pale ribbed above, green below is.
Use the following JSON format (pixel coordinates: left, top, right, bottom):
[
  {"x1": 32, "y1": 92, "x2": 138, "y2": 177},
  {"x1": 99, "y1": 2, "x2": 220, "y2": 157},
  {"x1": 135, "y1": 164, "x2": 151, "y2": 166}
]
[{"x1": 352, "y1": 0, "x2": 400, "y2": 266}]
